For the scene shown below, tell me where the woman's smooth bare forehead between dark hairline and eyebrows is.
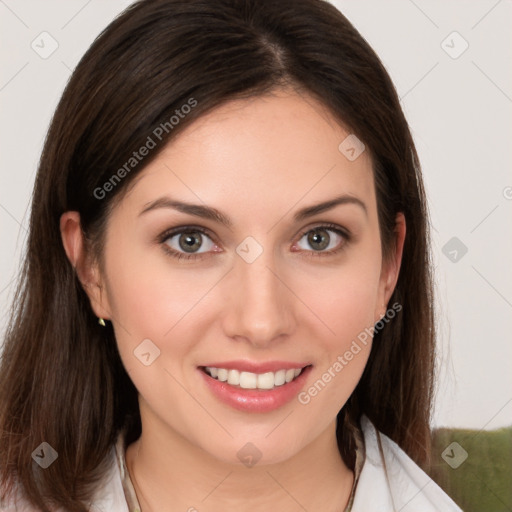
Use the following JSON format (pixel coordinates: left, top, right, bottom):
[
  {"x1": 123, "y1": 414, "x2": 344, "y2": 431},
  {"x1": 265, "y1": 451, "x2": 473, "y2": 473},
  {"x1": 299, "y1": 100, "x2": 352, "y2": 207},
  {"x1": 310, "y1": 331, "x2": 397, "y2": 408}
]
[{"x1": 119, "y1": 91, "x2": 375, "y2": 222}]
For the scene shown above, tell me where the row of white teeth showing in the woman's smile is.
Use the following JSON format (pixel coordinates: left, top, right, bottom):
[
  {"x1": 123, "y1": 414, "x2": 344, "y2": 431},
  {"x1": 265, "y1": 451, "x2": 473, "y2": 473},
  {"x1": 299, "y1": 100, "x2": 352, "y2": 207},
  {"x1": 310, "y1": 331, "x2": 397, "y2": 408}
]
[{"x1": 205, "y1": 366, "x2": 302, "y2": 389}]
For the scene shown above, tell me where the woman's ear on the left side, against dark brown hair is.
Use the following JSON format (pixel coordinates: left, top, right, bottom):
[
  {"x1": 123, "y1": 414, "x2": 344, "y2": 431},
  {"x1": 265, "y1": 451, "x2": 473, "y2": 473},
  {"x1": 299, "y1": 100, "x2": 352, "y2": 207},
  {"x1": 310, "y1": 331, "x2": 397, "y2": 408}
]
[{"x1": 60, "y1": 211, "x2": 111, "y2": 320}]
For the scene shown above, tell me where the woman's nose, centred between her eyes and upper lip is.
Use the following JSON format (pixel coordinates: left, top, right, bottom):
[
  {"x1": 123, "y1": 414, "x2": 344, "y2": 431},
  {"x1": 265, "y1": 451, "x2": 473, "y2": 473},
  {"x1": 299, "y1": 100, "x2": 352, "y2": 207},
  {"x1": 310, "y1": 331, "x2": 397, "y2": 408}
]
[{"x1": 223, "y1": 246, "x2": 297, "y2": 348}]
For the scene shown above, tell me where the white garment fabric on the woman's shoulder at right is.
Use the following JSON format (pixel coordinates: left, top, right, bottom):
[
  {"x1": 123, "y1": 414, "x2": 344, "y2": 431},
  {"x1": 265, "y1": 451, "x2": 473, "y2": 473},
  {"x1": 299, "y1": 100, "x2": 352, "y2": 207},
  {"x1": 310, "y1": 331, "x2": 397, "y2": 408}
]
[{"x1": 352, "y1": 416, "x2": 462, "y2": 512}]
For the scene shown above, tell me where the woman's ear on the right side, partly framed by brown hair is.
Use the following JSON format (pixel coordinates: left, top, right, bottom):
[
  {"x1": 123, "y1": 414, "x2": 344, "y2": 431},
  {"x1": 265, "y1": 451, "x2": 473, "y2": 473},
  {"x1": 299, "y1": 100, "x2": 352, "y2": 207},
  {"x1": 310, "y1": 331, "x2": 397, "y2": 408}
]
[{"x1": 375, "y1": 212, "x2": 406, "y2": 322}]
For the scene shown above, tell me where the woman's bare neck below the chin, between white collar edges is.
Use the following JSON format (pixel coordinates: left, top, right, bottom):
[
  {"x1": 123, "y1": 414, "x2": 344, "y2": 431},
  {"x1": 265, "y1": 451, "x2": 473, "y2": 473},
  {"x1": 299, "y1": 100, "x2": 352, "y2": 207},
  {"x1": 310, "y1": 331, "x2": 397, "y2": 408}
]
[{"x1": 126, "y1": 400, "x2": 354, "y2": 512}]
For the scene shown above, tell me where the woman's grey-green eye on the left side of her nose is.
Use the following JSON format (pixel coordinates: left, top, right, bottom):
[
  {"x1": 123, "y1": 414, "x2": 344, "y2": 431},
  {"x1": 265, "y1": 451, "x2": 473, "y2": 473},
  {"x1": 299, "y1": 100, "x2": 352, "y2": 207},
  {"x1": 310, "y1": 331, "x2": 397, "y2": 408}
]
[{"x1": 160, "y1": 226, "x2": 216, "y2": 259}]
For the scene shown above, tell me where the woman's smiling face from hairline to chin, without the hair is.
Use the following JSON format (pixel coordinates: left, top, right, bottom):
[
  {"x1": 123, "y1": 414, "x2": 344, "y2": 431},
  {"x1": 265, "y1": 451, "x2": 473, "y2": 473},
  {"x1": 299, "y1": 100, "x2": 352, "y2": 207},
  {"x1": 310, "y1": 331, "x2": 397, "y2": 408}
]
[{"x1": 80, "y1": 87, "x2": 401, "y2": 463}]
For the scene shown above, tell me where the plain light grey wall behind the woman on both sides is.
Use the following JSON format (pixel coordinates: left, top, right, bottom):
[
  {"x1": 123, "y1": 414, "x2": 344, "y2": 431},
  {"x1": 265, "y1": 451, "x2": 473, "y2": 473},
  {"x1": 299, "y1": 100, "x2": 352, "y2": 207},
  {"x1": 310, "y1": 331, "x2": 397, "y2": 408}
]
[{"x1": 0, "y1": 0, "x2": 512, "y2": 429}]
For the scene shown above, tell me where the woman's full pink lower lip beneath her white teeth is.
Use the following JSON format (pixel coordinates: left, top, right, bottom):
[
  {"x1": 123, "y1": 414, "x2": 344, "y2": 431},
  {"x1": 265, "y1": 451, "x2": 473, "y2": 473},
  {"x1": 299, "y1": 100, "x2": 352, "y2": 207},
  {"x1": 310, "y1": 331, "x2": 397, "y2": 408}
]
[{"x1": 198, "y1": 366, "x2": 312, "y2": 412}]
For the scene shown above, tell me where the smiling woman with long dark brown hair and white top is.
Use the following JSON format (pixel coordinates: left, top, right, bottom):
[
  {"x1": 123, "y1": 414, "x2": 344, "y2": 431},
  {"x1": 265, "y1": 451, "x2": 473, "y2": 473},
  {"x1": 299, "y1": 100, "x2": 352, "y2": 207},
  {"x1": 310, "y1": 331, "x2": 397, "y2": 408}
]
[{"x1": 0, "y1": 0, "x2": 460, "y2": 512}]
